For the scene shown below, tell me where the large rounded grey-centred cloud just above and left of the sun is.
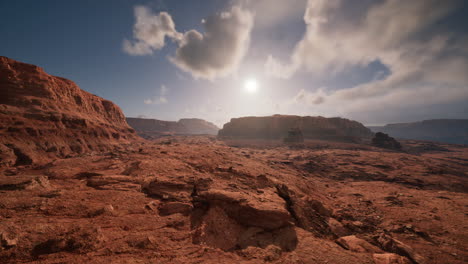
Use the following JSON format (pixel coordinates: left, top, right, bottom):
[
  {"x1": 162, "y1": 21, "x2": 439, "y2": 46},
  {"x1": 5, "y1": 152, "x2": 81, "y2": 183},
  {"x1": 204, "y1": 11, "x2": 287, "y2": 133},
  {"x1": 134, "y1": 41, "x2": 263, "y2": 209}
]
[{"x1": 171, "y1": 6, "x2": 253, "y2": 80}]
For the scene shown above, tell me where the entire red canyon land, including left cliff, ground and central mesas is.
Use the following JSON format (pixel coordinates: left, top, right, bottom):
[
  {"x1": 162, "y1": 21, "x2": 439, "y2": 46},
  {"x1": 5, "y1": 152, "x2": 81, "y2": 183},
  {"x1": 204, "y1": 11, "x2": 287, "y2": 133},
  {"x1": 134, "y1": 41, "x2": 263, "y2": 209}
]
[{"x1": 0, "y1": 57, "x2": 468, "y2": 264}]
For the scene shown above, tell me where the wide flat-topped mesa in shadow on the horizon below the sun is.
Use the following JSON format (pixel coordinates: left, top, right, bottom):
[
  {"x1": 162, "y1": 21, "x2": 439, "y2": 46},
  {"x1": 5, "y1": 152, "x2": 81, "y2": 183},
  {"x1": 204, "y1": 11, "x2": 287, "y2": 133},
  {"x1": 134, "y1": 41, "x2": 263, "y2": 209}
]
[{"x1": 218, "y1": 115, "x2": 373, "y2": 141}]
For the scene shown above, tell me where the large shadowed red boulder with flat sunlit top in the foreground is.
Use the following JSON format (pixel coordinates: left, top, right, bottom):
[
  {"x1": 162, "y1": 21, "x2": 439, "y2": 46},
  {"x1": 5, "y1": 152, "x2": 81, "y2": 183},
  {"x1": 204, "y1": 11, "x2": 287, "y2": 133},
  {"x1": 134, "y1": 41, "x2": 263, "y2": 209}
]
[{"x1": 191, "y1": 190, "x2": 298, "y2": 251}]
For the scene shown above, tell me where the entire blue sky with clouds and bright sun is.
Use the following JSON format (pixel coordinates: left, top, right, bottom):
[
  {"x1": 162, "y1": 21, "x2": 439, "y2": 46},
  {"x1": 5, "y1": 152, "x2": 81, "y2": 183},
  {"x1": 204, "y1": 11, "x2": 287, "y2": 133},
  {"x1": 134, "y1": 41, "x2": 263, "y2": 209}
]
[{"x1": 0, "y1": 0, "x2": 468, "y2": 126}]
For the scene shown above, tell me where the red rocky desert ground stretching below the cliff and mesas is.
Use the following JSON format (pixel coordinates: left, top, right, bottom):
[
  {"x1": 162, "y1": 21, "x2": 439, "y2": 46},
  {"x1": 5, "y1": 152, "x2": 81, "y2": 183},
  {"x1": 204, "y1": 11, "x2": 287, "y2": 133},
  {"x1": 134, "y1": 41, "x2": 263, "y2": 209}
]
[{"x1": 0, "y1": 136, "x2": 468, "y2": 264}]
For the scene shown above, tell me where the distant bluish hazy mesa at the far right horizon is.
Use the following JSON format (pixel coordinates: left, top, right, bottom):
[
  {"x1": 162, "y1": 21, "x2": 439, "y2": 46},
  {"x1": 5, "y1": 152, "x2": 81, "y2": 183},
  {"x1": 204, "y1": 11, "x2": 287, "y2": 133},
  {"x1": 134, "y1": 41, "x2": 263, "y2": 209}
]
[{"x1": 369, "y1": 119, "x2": 468, "y2": 144}]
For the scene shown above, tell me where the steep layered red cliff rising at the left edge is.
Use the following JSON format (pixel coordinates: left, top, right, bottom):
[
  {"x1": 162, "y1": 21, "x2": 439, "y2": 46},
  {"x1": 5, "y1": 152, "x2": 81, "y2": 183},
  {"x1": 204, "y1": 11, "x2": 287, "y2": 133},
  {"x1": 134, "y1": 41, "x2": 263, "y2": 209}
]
[{"x1": 0, "y1": 57, "x2": 137, "y2": 166}]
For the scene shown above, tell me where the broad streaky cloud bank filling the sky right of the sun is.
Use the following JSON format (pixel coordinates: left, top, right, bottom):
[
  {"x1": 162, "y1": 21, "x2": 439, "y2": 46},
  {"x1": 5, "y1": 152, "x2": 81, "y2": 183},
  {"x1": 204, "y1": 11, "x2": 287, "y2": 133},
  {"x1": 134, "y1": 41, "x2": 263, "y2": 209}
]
[{"x1": 265, "y1": 0, "x2": 468, "y2": 111}]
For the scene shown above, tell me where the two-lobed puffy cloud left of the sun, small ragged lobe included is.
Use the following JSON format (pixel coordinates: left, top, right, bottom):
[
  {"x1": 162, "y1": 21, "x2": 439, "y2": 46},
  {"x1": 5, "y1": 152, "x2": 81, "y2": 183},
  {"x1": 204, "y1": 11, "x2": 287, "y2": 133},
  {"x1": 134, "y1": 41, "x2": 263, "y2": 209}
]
[{"x1": 123, "y1": 6, "x2": 253, "y2": 80}]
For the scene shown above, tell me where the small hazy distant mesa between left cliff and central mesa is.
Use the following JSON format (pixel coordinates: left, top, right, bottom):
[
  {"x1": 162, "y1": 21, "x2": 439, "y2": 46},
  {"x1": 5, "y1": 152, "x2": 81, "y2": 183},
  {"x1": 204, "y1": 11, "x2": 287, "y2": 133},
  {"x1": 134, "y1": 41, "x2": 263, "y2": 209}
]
[{"x1": 127, "y1": 117, "x2": 219, "y2": 139}]
